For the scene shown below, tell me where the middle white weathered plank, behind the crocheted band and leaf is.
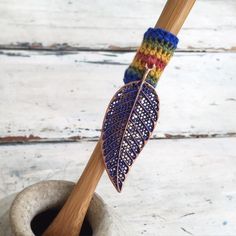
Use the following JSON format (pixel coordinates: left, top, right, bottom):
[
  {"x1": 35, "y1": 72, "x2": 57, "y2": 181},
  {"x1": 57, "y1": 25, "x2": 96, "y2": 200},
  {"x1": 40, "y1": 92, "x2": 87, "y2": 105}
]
[{"x1": 0, "y1": 51, "x2": 236, "y2": 142}]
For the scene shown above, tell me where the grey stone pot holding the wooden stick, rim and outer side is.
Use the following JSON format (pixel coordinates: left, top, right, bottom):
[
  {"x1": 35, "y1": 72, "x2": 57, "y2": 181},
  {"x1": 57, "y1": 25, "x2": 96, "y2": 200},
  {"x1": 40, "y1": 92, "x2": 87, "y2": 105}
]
[{"x1": 0, "y1": 180, "x2": 128, "y2": 236}]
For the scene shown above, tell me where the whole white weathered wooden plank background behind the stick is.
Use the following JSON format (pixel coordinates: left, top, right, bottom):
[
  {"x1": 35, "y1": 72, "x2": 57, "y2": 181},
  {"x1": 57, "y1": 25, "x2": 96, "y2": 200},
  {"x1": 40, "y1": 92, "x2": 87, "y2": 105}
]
[{"x1": 0, "y1": 0, "x2": 236, "y2": 236}]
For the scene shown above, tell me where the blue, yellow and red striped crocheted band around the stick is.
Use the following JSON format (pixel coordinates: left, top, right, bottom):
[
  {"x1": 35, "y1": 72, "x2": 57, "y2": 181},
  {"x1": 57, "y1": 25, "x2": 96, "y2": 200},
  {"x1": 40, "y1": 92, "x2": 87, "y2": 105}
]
[{"x1": 124, "y1": 28, "x2": 179, "y2": 87}]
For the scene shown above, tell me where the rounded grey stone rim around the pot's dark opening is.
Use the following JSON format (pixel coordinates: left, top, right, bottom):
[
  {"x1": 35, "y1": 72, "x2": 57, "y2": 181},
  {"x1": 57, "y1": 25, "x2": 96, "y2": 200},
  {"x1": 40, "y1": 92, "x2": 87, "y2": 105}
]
[{"x1": 7, "y1": 180, "x2": 123, "y2": 236}]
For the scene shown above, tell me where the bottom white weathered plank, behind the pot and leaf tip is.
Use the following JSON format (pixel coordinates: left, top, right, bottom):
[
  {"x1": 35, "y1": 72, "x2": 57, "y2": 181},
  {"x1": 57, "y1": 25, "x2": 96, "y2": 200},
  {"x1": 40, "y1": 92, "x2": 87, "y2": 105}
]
[{"x1": 0, "y1": 138, "x2": 236, "y2": 236}]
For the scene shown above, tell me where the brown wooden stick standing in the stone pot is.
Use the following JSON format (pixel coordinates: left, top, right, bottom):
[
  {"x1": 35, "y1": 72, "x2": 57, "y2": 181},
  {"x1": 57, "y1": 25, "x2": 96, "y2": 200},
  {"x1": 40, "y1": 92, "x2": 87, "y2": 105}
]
[{"x1": 43, "y1": 0, "x2": 195, "y2": 236}]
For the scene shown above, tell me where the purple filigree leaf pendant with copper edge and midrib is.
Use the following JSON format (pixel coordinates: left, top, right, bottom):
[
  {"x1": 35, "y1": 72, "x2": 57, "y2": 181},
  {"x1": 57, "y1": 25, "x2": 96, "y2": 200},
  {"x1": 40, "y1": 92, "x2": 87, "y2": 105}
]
[{"x1": 102, "y1": 81, "x2": 159, "y2": 192}]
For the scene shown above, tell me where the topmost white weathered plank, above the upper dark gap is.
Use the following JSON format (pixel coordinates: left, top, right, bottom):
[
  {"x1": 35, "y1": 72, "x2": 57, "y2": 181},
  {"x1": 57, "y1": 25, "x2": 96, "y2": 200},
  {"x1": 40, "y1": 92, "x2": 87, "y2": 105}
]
[{"x1": 0, "y1": 0, "x2": 236, "y2": 51}]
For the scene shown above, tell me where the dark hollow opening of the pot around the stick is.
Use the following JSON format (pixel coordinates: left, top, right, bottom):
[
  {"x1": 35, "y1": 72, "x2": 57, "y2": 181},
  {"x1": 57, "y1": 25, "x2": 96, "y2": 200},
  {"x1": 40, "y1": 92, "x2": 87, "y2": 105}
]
[{"x1": 31, "y1": 208, "x2": 93, "y2": 236}]
